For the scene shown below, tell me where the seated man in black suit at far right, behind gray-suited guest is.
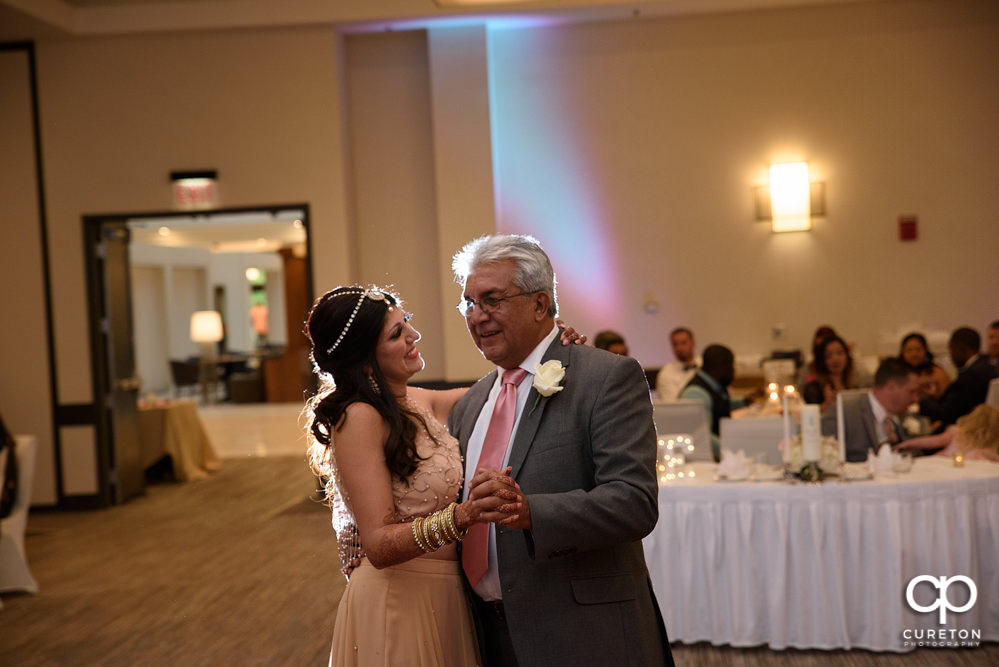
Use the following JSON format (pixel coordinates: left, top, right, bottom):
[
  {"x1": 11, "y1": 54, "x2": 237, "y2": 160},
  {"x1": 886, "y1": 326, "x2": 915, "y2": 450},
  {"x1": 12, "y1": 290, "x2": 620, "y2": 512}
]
[{"x1": 919, "y1": 327, "x2": 999, "y2": 426}]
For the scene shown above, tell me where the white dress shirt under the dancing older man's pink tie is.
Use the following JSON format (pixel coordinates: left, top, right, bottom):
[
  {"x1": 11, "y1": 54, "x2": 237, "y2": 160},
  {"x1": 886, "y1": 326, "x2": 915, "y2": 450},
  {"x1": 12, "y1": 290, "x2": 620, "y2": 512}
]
[{"x1": 462, "y1": 327, "x2": 558, "y2": 600}]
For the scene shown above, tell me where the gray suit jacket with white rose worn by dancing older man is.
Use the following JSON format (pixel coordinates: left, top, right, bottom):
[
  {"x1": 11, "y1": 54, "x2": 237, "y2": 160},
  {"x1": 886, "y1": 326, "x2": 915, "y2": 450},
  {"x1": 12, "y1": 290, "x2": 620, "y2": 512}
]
[{"x1": 448, "y1": 339, "x2": 672, "y2": 666}]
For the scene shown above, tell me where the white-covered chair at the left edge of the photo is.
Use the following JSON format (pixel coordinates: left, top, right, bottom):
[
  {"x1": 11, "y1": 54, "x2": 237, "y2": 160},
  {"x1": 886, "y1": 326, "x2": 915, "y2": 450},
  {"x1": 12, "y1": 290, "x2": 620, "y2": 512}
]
[{"x1": 0, "y1": 435, "x2": 38, "y2": 594}]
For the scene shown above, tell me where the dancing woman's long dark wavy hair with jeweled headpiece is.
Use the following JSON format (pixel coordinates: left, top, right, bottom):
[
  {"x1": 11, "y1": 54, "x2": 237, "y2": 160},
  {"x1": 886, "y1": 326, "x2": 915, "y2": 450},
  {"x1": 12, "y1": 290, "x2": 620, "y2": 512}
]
[{"x1": 305, "y1": 285, "x2": 426, "y2": 491}]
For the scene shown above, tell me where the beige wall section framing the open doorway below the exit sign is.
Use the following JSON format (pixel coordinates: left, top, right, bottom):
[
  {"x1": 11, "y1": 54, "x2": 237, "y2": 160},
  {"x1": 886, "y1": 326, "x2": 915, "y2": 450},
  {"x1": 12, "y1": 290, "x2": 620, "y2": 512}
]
[{"x1": 14, "y1": 28, "x2": 349, "y2": 503}]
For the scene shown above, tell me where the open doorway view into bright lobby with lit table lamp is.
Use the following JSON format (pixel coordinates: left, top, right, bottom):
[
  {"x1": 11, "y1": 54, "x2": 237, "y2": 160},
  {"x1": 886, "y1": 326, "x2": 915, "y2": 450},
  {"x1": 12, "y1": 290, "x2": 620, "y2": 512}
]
[{"x1": 126, "y1": 207, "x2": 311, "y2": 403}]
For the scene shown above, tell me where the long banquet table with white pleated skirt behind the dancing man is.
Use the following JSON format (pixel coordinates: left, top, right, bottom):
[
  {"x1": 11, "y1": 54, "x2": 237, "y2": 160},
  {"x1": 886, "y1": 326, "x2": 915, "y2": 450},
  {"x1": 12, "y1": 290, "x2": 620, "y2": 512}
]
[{"x1": 644, "y1": 457, "x2": 999, "y2": 652}]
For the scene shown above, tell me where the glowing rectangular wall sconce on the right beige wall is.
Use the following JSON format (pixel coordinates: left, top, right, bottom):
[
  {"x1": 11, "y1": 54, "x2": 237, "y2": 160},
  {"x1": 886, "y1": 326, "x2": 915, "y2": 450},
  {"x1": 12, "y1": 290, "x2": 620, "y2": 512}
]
[{"x1": 753, "y1": 162, "x2": 826, "y2": 232}]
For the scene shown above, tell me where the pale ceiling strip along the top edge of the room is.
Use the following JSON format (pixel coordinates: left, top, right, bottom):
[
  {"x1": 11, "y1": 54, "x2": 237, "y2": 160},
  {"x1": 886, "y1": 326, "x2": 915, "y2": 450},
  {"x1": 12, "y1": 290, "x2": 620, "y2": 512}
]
[{"x1": 0, "y1": 0, "x2": 887, "y2": 43}]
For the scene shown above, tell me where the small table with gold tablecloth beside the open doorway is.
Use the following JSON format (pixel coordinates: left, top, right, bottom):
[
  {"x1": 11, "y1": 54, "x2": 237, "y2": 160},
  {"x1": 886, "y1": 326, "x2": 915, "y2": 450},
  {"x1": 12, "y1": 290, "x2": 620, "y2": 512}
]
[{"x1": 139, "y1": 401, "x2": 221, "y2": 482}]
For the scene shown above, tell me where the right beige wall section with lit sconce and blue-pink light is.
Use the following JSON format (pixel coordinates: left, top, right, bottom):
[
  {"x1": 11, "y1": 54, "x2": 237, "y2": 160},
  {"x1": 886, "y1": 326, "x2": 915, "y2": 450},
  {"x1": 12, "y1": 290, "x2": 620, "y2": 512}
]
[{"x1": 491, "y1": 2, "x2": 999, "y2": 366}]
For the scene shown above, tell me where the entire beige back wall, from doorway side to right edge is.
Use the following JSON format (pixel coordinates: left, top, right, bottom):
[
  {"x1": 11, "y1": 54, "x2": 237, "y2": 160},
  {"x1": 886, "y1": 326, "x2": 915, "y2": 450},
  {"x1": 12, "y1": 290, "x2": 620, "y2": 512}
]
[{"x1": 2, "y1": 0, "x2": 999, "y2": 502}]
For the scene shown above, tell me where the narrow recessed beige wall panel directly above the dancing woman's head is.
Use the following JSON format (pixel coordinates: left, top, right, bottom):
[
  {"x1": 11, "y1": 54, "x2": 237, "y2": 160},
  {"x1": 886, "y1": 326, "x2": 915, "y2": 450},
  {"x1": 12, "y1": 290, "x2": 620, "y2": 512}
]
[{"x1": 348, "y1": 31, "x2": 444, "y2": 378}]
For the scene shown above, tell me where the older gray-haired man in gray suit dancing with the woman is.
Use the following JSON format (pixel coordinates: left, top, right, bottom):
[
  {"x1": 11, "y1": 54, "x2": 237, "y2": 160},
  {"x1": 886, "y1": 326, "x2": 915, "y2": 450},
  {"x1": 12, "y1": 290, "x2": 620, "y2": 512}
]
[{"x1": 449, "y1": 236, "x2": 673, "y2": 665}]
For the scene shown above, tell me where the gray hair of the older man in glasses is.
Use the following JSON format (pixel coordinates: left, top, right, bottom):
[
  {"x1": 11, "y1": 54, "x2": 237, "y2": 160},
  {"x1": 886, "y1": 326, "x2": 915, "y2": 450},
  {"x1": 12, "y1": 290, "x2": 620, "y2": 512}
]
[{"x1": 451, "y1": 234, "x2": 558, "y2": 317}]
